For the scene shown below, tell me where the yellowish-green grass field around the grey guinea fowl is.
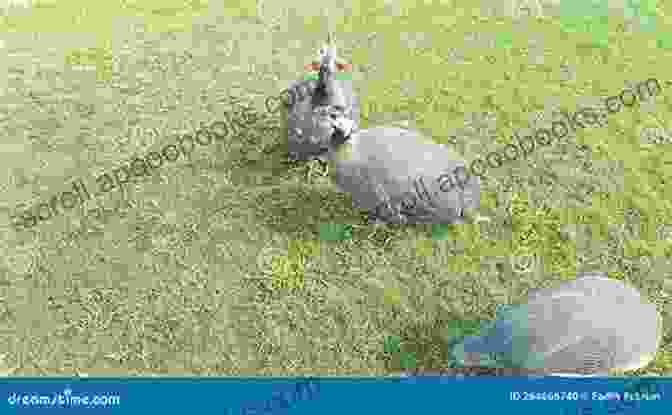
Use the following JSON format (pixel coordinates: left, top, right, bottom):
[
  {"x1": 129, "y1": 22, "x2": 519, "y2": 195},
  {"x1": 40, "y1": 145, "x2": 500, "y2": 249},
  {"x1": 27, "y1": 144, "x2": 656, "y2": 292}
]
[{"x1": 0, "y1": 0, "x2": 672, "y2": 376}]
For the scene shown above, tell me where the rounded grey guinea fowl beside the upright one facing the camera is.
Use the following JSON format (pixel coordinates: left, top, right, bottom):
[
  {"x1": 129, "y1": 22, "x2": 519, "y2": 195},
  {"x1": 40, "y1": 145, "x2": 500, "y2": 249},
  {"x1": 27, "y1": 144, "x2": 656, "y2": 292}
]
[{"x1": 329, "y1": 120, "x2": 487, "y2": 224}]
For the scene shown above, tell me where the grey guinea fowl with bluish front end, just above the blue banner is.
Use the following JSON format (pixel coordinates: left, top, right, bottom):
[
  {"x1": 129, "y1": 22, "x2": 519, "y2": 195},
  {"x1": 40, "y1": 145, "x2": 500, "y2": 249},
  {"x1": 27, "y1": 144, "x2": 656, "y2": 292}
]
[{"x1": 453, "y1": 272, "x2": 663, "y2": 376}]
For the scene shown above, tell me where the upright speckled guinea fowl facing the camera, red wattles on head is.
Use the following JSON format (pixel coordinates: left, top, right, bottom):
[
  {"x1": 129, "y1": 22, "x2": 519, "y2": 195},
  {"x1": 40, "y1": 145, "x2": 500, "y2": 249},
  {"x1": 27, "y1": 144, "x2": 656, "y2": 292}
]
[{"x1": 285, "y1": 34, "x2": 360, "y2": 161}]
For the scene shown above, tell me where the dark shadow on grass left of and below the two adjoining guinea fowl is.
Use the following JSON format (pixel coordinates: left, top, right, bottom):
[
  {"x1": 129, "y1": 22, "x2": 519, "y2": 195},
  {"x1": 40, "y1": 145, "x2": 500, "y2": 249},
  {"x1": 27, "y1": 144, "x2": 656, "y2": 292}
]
[{"x1": 214, "y1": 98, "x2": 468, "y2": 247}]
